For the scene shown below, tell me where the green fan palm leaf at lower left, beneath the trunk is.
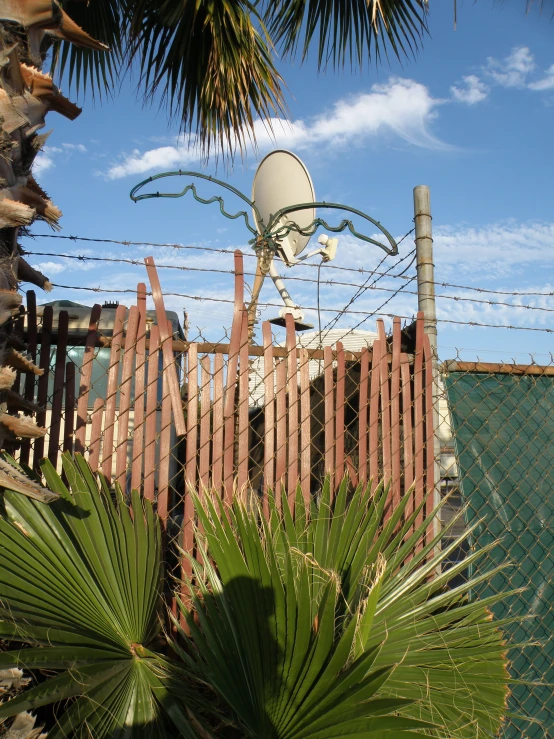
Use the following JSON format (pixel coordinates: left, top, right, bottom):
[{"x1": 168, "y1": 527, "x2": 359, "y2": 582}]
[{"x1": 0, "y1": 454, "x2": 207, "y2": 739}]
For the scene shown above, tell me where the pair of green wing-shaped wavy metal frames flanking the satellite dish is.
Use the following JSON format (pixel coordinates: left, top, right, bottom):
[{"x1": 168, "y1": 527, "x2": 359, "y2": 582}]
[{"x1": 130, "y1": 169, "x2": 398, "y2": 256}]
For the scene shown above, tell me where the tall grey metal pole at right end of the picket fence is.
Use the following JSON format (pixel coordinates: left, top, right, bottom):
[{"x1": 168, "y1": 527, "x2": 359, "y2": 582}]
[{"x1": 414, "y1": 185, "x2": 441, "y2": 523}]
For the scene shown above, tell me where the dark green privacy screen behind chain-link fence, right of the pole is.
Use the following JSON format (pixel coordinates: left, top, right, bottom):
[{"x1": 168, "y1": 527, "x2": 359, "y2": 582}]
[{"x1": 445, "y1": 372, "x2": 554, "y2": 739}]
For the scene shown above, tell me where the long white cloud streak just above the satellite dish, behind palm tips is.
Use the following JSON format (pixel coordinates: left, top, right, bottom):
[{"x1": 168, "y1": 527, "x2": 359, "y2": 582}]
[{"x1": 106, "y1": 78, "x2": 452, "y2": 179}]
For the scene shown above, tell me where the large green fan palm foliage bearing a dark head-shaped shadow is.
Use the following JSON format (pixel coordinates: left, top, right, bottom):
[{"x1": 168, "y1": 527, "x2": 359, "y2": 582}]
[{"x1": 175, "y1": 481, "x2": 508, "y2": 739}]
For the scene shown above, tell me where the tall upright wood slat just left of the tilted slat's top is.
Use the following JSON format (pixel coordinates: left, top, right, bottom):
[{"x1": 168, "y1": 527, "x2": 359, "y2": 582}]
[{"x1": 131, "y1": 282, "x2": 147, "y2": 490}]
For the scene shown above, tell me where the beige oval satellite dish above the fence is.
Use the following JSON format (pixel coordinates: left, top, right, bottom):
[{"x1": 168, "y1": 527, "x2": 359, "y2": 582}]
[{"x1": 252, "y1": 149, "x2": 316, "y2": 266}]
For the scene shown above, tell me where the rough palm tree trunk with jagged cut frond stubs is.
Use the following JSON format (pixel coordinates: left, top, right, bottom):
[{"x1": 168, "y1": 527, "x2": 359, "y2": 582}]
[{"x1": 0, "y1": 0, "x2": 106, "y2": 466}]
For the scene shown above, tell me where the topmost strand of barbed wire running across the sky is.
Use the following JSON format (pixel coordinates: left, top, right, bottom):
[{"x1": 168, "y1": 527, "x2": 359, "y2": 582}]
[{"x1": 28, "y1": 234, "x2": 554, "y2": 298}]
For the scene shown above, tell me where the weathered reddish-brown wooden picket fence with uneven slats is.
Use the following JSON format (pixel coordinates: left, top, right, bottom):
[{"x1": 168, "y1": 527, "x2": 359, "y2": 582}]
[{"x1": 15, "y1": 251, "x2": 434, "y2": 549}]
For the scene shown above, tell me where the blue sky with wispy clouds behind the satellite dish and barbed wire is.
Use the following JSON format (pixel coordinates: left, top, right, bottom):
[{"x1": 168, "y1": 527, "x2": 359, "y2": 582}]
[{"x1": 23, "y1": 0, "x2": 554, "y2": 363}]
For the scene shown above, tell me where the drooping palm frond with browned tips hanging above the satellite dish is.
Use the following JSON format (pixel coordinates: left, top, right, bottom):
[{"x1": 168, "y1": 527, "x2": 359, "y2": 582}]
[{"x1": 129, "y1": 0, "x2": 284, "y2": 153}]
